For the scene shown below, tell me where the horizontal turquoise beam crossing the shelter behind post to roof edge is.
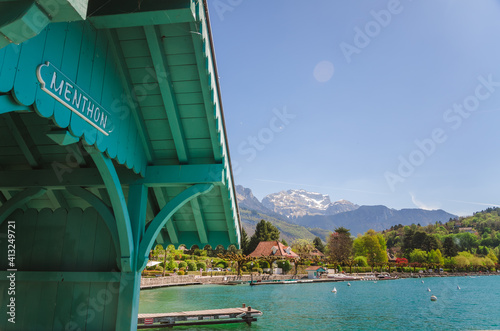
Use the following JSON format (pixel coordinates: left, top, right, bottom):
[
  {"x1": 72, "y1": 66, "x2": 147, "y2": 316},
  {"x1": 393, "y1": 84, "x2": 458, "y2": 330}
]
[{"x1": 0, "y1": 164, "x2": 224, "y2": 189}]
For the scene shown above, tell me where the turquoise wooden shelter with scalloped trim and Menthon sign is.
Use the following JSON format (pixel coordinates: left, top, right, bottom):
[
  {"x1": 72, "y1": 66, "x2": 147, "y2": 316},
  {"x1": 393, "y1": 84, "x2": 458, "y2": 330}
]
[{"x1": 0, "y1": 0, "x2": 240, "y2": 330}]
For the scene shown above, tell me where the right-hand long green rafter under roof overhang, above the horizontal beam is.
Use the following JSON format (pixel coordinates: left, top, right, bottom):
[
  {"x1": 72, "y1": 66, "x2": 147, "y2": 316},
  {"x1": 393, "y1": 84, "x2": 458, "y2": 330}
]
[{"x1": 144, "y1": 25, "x2": 189, "y2": 164}]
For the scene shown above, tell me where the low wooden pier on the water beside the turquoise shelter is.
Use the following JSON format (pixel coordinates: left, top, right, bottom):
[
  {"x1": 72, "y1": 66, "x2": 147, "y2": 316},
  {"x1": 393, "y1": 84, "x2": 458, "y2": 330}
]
[{"x1": 137, "y1": 304, "x2": 262, "y2": 329}]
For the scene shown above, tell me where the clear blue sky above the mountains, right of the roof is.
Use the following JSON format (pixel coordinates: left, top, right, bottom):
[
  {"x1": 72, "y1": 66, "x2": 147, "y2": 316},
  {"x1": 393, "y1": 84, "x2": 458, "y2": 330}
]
[{"x1": 209, "y1": 0, "x2": 500, "y2": 215}]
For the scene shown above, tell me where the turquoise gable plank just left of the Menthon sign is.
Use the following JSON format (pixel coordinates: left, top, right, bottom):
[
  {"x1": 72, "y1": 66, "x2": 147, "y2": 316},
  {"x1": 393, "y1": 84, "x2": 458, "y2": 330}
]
[{"x1": 12, "y1": 29, "x2": 47, "y2": 106}]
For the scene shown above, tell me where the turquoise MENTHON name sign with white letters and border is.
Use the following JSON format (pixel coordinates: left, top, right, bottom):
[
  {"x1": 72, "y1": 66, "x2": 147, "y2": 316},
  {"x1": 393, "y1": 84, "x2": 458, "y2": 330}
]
[{"x1": 36, "y1": 62, "x2": 113, "y2": 136}]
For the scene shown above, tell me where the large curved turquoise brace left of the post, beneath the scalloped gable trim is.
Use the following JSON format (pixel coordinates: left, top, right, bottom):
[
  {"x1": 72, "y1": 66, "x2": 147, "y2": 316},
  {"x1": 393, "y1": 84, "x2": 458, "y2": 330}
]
[{"x1": 86, "y1": 147, "x2": 134, "y2": 272}]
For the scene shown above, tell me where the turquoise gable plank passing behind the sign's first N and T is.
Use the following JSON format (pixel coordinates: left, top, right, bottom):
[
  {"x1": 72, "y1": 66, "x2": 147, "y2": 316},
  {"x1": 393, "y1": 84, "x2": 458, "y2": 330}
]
[{"x1": 69, "y1": 24, "x2": 96, "y2": 137}]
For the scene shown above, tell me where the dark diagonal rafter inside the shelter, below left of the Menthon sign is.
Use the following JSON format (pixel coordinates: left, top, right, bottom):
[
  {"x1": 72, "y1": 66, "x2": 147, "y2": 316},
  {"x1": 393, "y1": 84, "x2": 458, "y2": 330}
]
[{"x1": 4, "y1": 113, "x2": 40, "y2": 168}]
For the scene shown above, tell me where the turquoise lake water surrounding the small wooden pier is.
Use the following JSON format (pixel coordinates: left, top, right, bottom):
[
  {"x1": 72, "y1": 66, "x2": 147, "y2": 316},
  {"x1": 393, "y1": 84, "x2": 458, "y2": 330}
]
[{"x1": 139, "y1": 276, "x2": 500, "y2": 330}]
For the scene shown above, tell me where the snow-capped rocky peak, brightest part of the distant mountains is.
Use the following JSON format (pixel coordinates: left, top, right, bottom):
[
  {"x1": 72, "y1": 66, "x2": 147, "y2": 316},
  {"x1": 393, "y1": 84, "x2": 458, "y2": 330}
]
[{"x1": 262, "y1": 190, "x2": 359, "y2": 218}]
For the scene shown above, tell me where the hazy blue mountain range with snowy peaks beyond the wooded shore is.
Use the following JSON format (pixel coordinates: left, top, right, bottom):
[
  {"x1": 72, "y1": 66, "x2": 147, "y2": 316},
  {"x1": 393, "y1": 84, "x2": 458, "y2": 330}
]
[{"x1": 236, "y1": 185, "x2": 456, "y2": 240}]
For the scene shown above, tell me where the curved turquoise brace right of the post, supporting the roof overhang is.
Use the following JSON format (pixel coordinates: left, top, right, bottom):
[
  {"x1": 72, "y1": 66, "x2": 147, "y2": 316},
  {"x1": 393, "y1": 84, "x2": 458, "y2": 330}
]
[{"x1": 137, "y1": 184, "x2": 214, "y2": 270}]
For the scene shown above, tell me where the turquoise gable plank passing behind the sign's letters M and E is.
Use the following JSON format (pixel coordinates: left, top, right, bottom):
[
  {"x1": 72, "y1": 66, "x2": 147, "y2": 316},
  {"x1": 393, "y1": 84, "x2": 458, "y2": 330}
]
[{"x1": 54, "y1": 22, "x2": 83, "y2": 128}]
